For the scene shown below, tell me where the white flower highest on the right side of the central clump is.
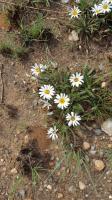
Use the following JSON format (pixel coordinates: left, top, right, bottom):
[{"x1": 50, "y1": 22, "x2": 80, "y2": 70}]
[{"x1": 69, "y1": 72, "x2": 84, "y2": 87}]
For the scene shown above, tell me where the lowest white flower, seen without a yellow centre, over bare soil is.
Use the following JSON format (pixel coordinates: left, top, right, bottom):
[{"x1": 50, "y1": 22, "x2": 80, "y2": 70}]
[{"x1": 47, "y1": 126, "x2": 58, "y2": 140}]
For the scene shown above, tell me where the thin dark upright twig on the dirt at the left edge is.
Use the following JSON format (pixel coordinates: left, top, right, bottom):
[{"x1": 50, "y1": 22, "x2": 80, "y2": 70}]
[{"x1": 0, "y1": 64, "x2": 4, "y2": 104}]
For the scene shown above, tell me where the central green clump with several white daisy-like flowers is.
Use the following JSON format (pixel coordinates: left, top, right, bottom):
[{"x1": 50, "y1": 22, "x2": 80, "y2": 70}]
[{"x1": 31, "y1": 64, "x2": 112, "y2": 143}]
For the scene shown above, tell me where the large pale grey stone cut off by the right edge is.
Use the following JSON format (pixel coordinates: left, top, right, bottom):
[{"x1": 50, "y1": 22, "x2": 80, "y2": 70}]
[{"x1": 101, "y1": 118, "x2": 112, "y2": 137}]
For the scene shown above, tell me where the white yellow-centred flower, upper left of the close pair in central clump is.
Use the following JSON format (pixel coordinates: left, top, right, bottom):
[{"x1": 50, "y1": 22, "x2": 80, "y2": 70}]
[{"x1": 39, "y1": 85, "x2": 55, "y2": 100}]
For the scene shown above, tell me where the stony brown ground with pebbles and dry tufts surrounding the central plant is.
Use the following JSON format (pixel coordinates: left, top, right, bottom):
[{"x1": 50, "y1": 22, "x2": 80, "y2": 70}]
[{"x1": 0, "y1": 1, "x2": 112, "y2": 200}]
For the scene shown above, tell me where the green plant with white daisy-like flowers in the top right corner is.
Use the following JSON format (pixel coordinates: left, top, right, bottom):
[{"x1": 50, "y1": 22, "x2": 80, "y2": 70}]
[{"x1": 63, "y1": 0, "x2": 112, "y2": 40}]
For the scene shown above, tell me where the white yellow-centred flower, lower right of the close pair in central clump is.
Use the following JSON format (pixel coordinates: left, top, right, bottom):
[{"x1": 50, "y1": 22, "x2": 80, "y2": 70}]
[{"x1": 54, "y1": 93, "x2": 70, "y2": 110}]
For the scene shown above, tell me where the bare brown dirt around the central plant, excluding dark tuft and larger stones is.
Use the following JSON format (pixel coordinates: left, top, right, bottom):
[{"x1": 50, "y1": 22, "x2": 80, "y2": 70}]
[{"x1": 0, "y1": 0, "x2": 112, "y2": 200}]
